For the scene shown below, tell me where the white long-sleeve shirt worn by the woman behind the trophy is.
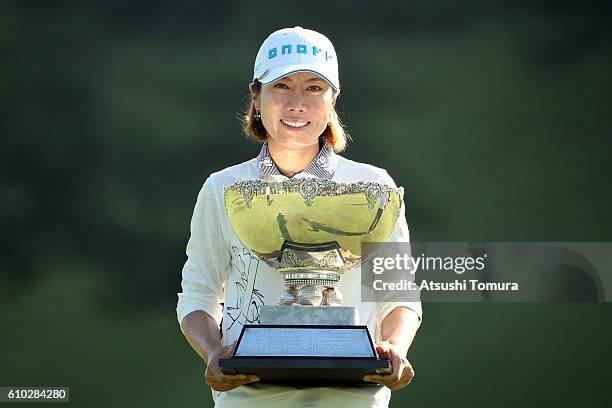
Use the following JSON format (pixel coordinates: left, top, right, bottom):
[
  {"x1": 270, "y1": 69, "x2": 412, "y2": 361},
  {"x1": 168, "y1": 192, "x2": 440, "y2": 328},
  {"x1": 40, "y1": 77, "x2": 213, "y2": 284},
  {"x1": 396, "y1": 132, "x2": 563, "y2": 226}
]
[{"x1": 176, "y1": 151, "x2": 422, "y2": 408}]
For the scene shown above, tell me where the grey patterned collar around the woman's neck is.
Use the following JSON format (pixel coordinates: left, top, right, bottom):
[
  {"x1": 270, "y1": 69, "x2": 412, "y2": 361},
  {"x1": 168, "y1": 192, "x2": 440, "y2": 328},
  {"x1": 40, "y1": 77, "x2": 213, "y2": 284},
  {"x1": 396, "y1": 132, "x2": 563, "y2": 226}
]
[{"x1": 257, "y1": 142, "x2": 338, "y2": 180}]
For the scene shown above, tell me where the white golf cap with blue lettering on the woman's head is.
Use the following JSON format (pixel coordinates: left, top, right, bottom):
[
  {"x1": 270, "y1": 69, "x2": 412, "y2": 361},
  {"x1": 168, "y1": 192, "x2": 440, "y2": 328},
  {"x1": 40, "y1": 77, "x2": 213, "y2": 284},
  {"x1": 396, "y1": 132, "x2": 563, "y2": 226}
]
[{"x1": 253, "y1": 27, "x2": 340, "y2": 90}]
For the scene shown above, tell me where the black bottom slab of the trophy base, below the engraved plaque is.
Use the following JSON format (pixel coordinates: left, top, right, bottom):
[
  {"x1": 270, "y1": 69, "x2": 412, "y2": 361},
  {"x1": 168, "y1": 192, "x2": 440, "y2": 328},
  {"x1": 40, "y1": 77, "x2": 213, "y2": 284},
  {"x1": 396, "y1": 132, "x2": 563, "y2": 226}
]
[{"x1": 219, "y1": 357, "x2": 391, "y2": 387}]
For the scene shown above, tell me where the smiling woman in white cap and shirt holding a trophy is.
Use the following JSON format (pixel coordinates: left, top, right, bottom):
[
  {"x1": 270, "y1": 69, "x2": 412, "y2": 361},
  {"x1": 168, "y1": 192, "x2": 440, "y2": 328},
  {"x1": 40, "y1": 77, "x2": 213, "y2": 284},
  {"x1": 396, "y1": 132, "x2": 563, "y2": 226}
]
[{"x1": 177, "y1": 27, "x2": 421, "y2": 408}]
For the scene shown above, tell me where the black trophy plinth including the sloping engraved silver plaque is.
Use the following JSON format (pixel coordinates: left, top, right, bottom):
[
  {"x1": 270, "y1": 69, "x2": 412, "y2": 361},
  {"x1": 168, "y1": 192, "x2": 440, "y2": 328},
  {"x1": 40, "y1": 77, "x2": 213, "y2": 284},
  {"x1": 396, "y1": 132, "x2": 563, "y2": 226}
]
[{"x1": 219, "y1": 326, "x2": 391, "y2": 386}]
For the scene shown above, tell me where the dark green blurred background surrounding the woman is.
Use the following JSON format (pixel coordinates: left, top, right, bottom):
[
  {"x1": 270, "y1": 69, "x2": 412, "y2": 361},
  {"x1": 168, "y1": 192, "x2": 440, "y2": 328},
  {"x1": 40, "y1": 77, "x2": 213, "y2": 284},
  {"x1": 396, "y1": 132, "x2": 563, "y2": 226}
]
[{"x1": 0, "y1": 0, "x2": 612, "y2": 408}]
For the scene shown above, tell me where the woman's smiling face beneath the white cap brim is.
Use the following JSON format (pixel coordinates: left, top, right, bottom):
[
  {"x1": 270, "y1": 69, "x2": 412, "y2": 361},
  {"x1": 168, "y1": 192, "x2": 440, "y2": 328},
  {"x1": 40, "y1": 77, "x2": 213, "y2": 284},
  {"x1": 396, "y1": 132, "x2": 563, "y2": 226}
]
[{"x1": 253, "y1": 72, "x2": 336, "y2": 149}]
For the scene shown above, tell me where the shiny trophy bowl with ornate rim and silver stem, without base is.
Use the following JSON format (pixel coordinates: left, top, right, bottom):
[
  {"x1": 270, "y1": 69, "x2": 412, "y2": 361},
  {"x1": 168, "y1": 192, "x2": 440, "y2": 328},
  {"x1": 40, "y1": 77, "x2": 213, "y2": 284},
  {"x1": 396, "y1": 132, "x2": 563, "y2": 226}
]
[{"x1": 224, "y1": 178, "x2": 403, "y2": 305}]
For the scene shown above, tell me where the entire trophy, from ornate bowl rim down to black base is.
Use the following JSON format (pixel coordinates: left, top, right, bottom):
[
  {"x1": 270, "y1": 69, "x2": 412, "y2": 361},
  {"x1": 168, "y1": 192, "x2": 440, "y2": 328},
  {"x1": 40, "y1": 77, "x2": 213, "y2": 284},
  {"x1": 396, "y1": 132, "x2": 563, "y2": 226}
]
[{"x1": 220, "y1": 178, "x2": 403, "y2": 382}]
